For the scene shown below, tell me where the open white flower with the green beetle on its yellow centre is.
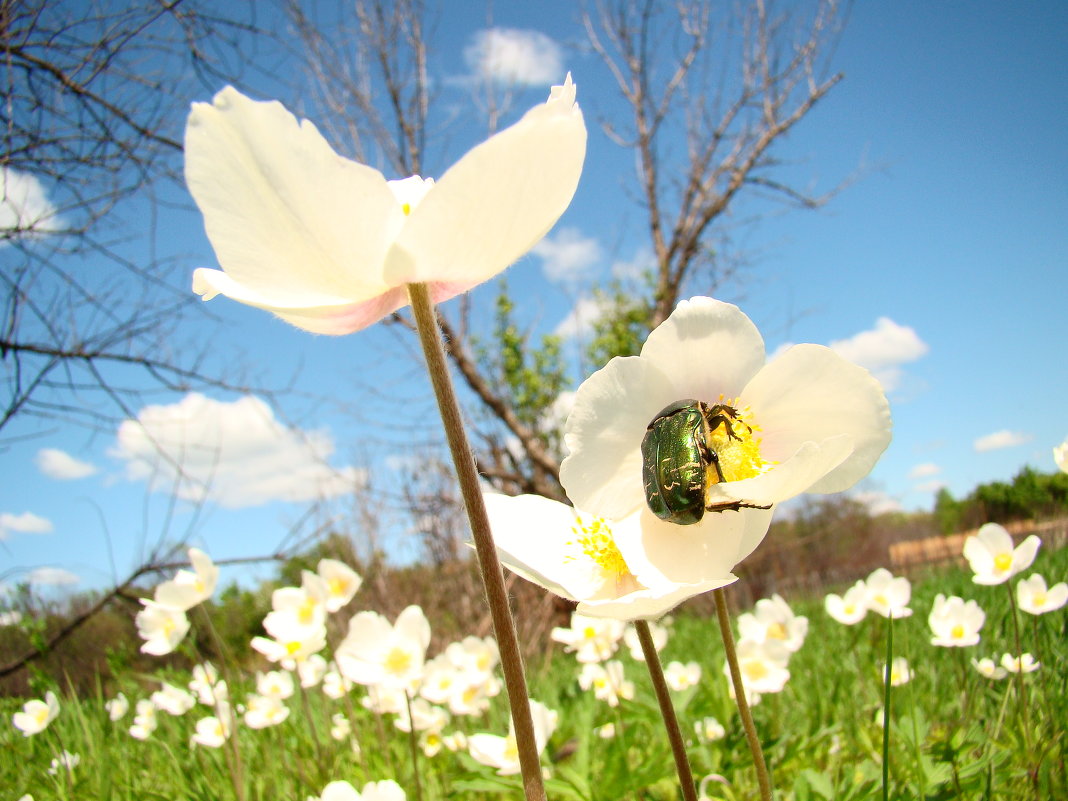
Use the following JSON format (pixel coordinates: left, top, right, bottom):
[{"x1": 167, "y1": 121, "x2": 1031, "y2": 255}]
[{"x1": 560, "y1": 297, "x2": 891, "y2": 529}]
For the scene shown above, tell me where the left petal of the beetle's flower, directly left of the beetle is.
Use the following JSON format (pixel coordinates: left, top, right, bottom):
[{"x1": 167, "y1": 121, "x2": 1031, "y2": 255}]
[{"x1": 560, "y1": 356, "x2": 680, "y2": 520}]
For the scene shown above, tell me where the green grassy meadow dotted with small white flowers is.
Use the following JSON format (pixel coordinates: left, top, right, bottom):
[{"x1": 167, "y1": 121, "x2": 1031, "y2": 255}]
[{"x1": 0, "y1": 534, "x2": 1068, "y2": 801}]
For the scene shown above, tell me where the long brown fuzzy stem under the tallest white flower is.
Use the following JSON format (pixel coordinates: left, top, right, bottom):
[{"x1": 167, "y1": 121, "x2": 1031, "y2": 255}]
[{"x1": 408, "y1": 283, "x2": 545, "y2": 801}]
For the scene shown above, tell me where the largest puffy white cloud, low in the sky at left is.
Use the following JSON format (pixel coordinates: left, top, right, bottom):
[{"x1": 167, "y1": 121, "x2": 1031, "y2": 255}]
[{"x1": 111, "y1": 393, "x2": 365, "y2": 508}]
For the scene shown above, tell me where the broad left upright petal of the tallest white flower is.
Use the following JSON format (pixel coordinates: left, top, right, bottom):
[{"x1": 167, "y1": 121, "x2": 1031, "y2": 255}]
[{"x1": 186, "y1": 87, "x2": 403, "y2": 307}]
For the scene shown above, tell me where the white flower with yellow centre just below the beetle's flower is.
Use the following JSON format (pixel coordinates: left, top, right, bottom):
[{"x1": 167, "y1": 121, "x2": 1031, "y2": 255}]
[{"x1": 484, "y1": 493, "x2": 771, "y2": 619}]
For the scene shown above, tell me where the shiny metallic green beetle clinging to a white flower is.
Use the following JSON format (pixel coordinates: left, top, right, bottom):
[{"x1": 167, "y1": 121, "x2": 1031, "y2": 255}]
[{"x1": 642, "y1": 398, "x2": 769, "y2": 525}]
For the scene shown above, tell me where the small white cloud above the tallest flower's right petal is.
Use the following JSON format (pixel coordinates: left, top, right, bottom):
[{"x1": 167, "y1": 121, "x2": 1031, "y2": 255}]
[{"x1": 464, "y1": 28, "x2": 564, "y2": 87}]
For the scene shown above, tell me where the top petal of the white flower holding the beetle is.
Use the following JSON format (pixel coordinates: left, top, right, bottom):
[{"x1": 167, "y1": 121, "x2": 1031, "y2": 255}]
[{"x1": 642, "y1": 297, "x2": 764, "y2": 401}]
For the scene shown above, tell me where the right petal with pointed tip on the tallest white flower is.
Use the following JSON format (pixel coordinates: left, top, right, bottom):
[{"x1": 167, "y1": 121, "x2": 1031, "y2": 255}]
[{"x1": 386, "y1": 75, "x2": 586, "y2": 286}]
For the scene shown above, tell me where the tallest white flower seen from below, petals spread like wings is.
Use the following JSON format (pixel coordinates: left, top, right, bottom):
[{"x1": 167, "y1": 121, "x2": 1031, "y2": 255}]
[{"x1": 185, "y1": 75, "x2": 586, "y2": 334}]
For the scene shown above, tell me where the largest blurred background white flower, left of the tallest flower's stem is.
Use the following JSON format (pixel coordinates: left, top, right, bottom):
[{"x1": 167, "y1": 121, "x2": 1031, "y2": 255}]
[{"x1": 334, "y1": 606, "x2": 430, "y2": 689}]
